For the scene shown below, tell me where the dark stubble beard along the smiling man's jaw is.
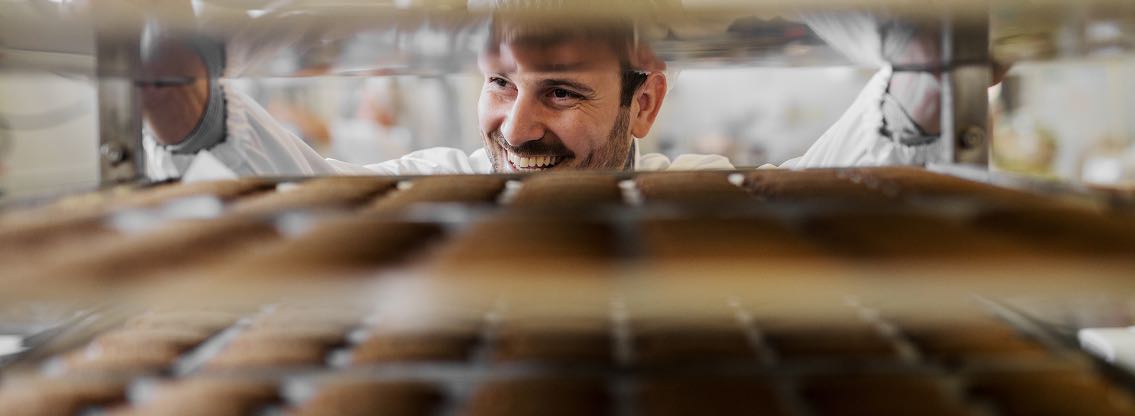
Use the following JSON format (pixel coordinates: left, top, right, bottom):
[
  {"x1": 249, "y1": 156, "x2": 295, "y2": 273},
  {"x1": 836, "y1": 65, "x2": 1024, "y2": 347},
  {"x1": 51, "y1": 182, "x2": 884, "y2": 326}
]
[{"x1": 482, "y1": 107, "x2": 634, "y2": 173}]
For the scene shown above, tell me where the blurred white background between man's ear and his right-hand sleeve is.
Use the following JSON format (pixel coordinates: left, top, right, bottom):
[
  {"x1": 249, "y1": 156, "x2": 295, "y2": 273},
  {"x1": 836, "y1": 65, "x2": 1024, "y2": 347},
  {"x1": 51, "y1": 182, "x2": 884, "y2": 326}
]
[{"x1": 642, "y1": 67, "x2": 874, "y2": 165}]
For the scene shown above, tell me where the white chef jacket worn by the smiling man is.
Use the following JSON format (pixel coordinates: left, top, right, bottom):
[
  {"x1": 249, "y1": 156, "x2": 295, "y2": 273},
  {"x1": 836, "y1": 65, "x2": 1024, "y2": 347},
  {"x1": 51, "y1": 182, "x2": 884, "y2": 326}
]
[{"x1": 144, "y1": 67, "x2": 938, "y2": 180}]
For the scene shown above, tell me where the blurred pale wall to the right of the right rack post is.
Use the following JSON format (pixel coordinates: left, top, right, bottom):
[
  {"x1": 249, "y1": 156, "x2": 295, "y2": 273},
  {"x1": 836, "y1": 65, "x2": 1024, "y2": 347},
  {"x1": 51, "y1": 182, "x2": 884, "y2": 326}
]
[{"x1": 992, "y1": 57, "x2": 1135, "y2": 186}]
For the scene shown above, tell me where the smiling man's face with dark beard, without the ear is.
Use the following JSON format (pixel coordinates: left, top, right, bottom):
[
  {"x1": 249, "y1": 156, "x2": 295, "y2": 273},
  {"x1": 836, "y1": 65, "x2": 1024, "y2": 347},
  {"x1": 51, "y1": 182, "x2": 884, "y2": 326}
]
[{"x1": 478, "y1": 34, "x2": 633, "y2": 172}]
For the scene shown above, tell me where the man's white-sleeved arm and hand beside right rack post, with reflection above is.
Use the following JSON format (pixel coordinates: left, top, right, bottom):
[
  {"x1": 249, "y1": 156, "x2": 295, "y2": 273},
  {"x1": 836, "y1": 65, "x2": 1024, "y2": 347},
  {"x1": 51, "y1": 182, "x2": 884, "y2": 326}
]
[{"x1": 782, "y1": 11, "x2": 941, "y2": 168}]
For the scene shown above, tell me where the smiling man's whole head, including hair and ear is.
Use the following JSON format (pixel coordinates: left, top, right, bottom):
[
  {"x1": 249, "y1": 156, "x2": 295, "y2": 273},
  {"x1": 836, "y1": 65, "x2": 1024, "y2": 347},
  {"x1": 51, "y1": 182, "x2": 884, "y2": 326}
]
[{"x1": 478, "y1": 25, "x2": 666, "y2": 172}]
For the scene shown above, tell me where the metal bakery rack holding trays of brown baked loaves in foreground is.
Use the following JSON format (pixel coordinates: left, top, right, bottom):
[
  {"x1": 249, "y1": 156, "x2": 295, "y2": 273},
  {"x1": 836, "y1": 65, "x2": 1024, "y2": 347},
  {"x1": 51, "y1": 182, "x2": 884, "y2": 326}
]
[{"x1": 0, "y1": 1, "x2": 1135, "y2": 415}]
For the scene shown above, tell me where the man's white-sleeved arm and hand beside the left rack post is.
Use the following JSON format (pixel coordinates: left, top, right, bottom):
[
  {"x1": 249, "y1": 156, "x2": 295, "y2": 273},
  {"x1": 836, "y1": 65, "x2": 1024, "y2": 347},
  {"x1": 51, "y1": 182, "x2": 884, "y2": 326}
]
[{"x1": 141, "y1": 40, "x2": 373, "y2": 179}]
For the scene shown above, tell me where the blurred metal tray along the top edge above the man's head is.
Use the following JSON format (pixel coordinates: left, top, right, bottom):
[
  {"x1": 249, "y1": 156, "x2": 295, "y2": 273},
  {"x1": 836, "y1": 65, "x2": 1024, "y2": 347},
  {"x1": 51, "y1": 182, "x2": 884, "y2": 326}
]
[{"x1": 0, "y1": 0, "x2": 1135, "y2": 77}]
